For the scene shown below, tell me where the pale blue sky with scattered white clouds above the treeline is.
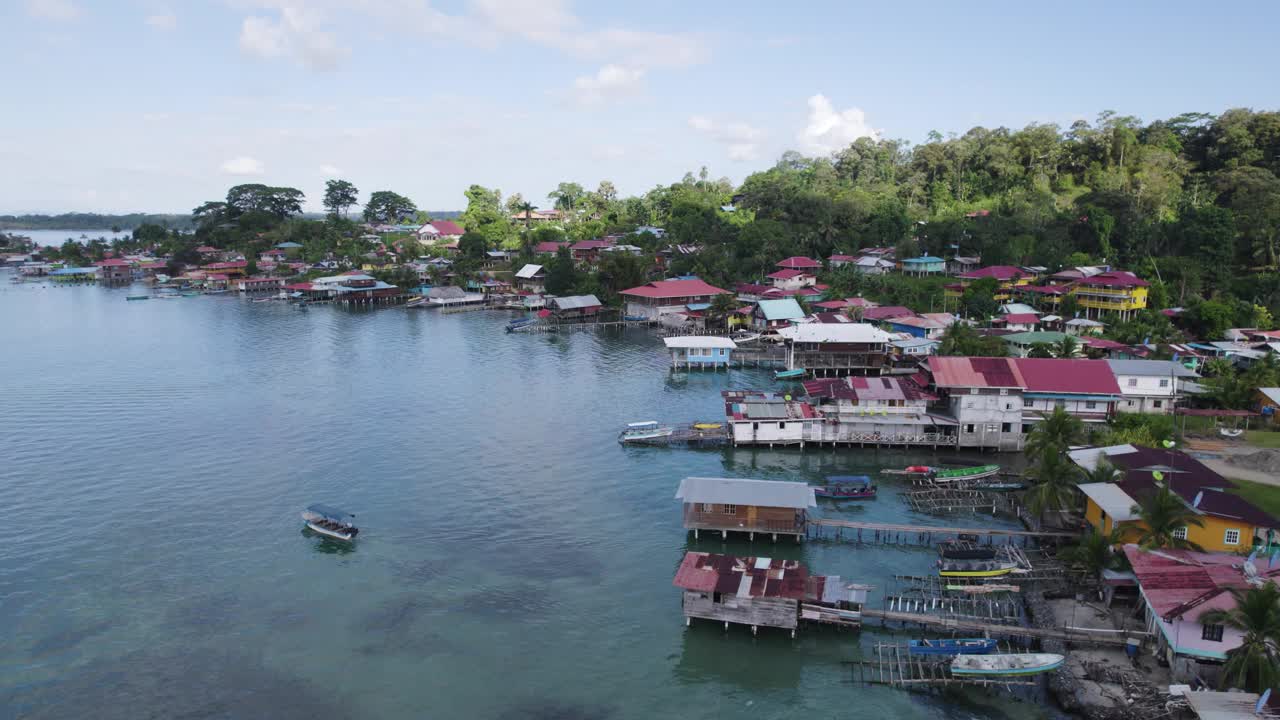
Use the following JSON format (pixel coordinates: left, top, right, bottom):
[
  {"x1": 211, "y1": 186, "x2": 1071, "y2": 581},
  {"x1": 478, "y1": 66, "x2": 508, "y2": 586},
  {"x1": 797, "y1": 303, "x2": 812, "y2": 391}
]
[{"x1": 0, "y1": 0, "x2": 1280, "y2": 214}]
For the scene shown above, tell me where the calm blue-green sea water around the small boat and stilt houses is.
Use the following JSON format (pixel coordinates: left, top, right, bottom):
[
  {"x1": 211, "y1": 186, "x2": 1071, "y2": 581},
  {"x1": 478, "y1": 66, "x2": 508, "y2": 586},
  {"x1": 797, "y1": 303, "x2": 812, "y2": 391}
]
[{"x1": 0, "y1": 273, "x2": 1048, "y2": 719}]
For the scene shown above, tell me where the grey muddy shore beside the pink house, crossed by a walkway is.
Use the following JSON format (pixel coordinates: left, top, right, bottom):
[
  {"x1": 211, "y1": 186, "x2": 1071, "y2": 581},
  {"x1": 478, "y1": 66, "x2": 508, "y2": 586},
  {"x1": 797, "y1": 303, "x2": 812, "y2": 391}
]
[{"x1": 1050, "y1": 598, "x2": 1170, "y2": 707}]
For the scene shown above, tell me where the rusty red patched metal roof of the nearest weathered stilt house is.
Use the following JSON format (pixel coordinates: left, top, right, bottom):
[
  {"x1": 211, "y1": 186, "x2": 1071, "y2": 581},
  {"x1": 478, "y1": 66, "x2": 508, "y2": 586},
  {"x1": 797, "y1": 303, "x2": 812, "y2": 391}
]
[{"x1": 672, "y1": 552, "x2": 809, "y2": 600}]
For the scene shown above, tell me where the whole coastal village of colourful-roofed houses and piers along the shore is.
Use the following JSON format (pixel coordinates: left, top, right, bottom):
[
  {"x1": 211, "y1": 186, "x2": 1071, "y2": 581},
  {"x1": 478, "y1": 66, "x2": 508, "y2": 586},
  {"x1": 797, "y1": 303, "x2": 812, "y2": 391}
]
[{"x1": 4, "y1": 219, "x2": 1280, "y2": 719}]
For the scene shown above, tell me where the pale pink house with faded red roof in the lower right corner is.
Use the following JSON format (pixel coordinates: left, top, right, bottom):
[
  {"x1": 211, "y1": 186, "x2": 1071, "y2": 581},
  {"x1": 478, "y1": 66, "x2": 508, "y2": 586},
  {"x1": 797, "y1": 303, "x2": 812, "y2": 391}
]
[{"x1": 1124, "y1": 544, "x2": 1280, "y2": 681}]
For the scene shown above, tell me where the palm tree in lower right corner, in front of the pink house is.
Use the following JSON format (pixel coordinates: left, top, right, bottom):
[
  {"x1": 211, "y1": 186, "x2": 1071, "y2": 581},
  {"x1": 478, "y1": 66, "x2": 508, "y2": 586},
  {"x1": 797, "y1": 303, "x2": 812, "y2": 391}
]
[{"x1": 1199, "y1": 583, "x2": 1280, "y2": 693}]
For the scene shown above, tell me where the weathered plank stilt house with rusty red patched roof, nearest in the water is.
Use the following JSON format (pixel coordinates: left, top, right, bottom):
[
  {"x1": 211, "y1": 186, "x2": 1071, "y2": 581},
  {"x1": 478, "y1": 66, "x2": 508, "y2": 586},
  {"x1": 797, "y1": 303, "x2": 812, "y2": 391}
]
[{"x1": 672, "y1": 552, "x2": 868, "y2": 638}]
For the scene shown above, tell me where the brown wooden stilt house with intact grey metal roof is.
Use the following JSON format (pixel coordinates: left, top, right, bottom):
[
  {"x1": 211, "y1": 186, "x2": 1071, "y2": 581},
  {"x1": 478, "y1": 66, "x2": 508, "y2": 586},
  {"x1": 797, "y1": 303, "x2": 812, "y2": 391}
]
[{"x1": 676, "y1": 478, "x2": 818, "y2": 541}]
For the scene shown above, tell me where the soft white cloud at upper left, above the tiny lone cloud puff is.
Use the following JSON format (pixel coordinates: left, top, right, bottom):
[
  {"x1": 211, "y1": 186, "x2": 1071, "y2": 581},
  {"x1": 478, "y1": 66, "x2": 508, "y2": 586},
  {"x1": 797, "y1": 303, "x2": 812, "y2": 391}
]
[{"x1": 239, "y1": 5, "x2": 351, "y2": 70}]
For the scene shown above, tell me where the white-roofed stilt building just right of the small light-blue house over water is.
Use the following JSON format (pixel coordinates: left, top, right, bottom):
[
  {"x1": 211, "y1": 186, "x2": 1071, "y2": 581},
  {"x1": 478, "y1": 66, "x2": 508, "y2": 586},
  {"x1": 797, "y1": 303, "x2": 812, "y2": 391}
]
[{"x1": 778, "y1": 323, "x2": 893, "y2": 377}]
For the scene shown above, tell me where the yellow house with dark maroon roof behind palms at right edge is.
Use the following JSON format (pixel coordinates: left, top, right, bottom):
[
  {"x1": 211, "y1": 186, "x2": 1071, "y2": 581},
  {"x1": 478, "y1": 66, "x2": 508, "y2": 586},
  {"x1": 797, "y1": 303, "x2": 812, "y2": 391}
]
[{"x1": 1069, "y1": 445, "x2": 1280, "y2": 552}]
